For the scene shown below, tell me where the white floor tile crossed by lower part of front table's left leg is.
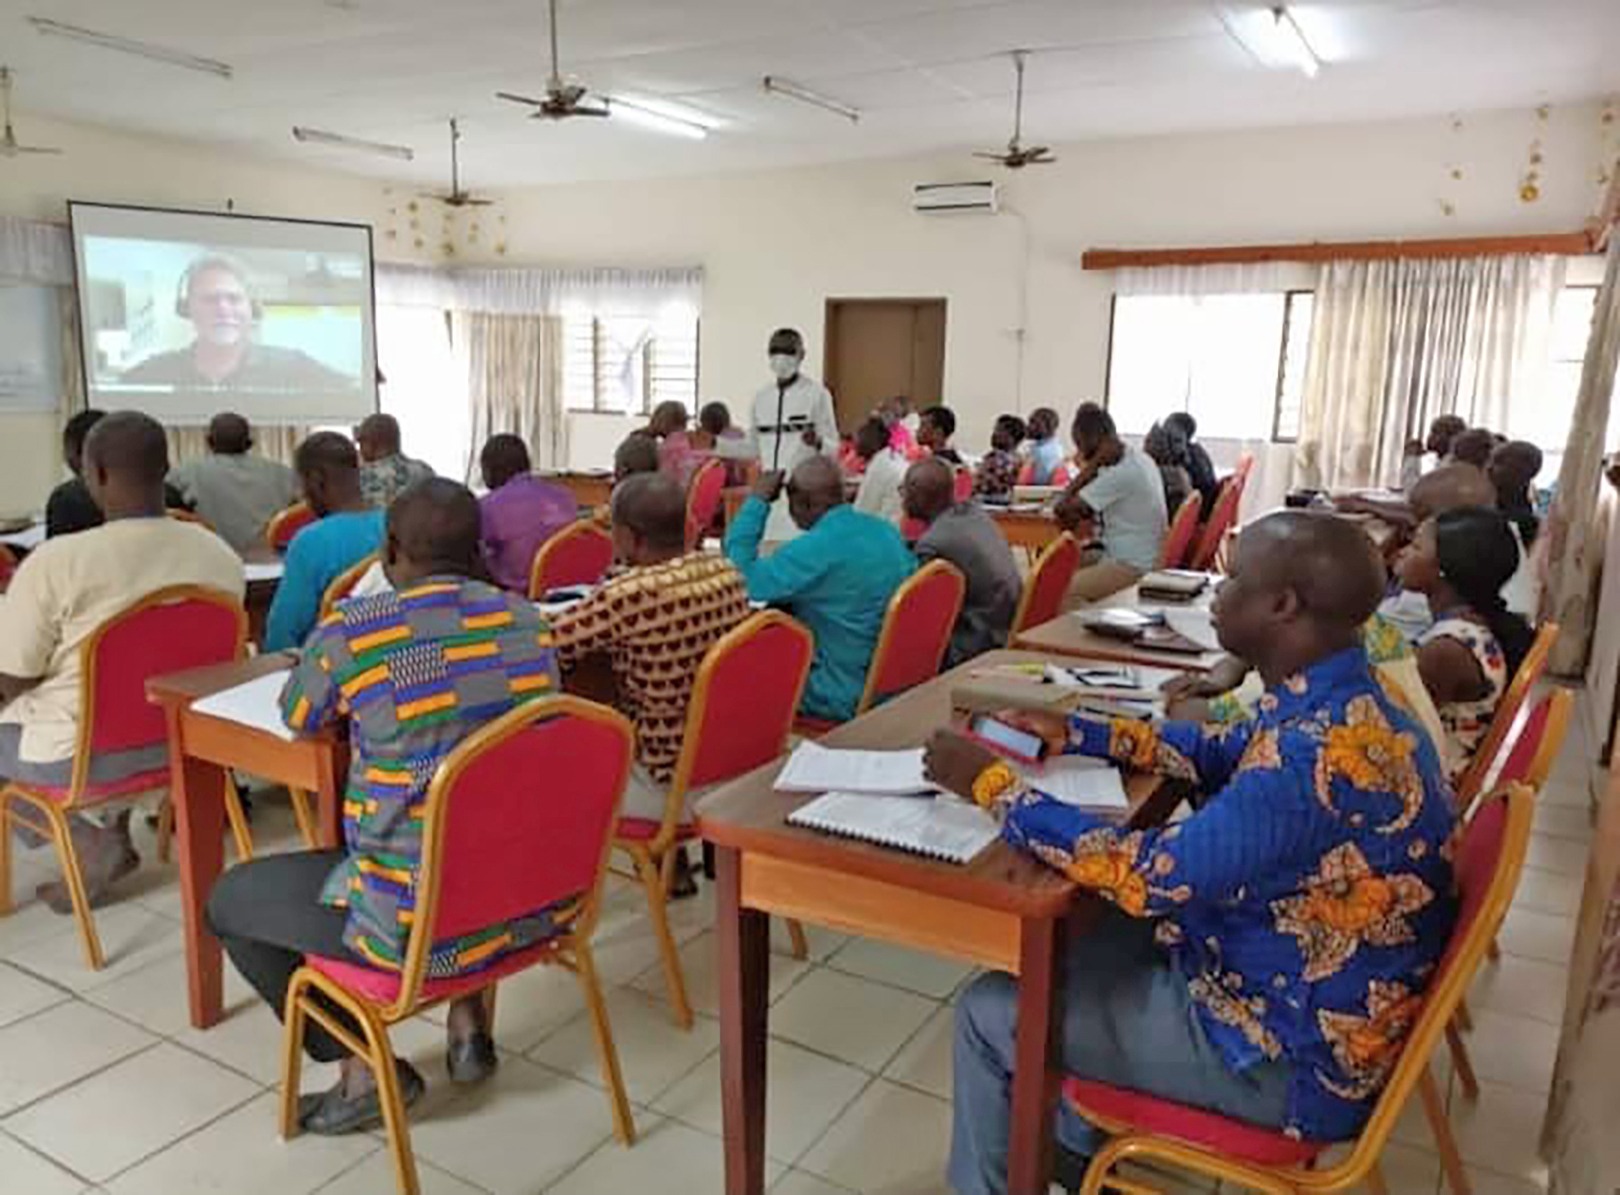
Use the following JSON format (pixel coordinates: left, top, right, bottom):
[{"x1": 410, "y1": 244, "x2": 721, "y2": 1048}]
[{"x1": 653, "y1": 1040, "x2": 868, "y2": 1164}]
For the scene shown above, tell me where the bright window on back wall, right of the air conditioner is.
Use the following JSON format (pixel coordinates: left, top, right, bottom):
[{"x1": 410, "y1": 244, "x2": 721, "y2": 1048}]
[{"x1": 1108, "y1": 290, "x2": 1315, "y2": 440}]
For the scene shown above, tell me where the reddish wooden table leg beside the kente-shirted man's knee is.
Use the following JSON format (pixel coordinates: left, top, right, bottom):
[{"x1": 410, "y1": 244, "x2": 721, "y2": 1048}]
[{"x1": 168, "y1": 716, "x2": 225, "y2": 1028}]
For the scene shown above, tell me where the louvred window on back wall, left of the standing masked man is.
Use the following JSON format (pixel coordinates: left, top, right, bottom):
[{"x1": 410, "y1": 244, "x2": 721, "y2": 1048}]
[{"x1": 562, "y1": 311, "x2": 698, "y2": 415}]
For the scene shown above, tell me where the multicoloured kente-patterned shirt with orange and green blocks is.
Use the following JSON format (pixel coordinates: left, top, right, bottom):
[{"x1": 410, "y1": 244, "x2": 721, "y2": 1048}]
[{"x1": 282, "y1": 576, "x2": 580, "y2": 978}]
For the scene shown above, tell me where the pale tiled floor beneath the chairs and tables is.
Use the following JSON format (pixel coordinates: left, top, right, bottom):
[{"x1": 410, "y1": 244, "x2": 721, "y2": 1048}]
[{"x1": 0, "y1": 702, "x2": 1591, "y2": 1195}]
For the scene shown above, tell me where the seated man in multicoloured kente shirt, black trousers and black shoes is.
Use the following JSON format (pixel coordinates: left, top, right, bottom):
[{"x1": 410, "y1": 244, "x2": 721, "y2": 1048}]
[{"x1": 207, "y1": 478, "x2": 573, "y2": 1133}]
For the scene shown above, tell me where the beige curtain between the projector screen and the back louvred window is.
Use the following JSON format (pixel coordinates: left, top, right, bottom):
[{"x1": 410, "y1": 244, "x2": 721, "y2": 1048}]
[{"x1": 450, "y1": 311, "x2": 569, "y2": 481}]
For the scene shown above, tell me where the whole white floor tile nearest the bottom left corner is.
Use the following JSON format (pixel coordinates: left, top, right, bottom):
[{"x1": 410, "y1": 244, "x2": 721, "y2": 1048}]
[{"x1": 5, "y1": 1043, "x2": 259, "y2": 1182}]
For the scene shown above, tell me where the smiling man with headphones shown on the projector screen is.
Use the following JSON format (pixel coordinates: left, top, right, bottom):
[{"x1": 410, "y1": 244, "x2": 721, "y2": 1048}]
[{"x1": 118, "y1": 253, "x2": 360, "y2": 392}]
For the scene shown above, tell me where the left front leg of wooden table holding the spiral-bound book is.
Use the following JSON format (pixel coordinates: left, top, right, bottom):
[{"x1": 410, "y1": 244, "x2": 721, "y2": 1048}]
[{"x1": 714, "y1": 847, "x2": 771, "y2": 1195}]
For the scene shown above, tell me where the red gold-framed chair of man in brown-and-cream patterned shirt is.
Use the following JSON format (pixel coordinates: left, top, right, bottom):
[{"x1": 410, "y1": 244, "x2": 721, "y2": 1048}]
[{"x1": 614, "y1": 610, "x2": 815, "y2": 1028}]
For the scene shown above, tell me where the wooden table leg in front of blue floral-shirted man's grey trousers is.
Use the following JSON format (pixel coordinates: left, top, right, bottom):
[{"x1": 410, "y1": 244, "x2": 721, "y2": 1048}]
[{"x1": 1008, "y1": 918, "x2": 1063, "y2": 1195}]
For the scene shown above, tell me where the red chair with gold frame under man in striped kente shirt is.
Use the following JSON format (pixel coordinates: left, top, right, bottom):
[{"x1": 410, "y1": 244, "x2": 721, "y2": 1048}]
[{"x1": 280, "y1": 696, "x2": 635, "y2": 1192}]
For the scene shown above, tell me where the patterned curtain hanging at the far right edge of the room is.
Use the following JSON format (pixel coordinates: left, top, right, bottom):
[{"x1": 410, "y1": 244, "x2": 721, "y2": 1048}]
[{"x1": 1541, "y1": 236, "x2": 1620, "y2": 675}]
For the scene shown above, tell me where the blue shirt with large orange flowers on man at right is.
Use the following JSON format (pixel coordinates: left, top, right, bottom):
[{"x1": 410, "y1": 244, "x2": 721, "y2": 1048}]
[{"x1": 975, "y1": 648, "x2": 1456, "y2": 1142}]
